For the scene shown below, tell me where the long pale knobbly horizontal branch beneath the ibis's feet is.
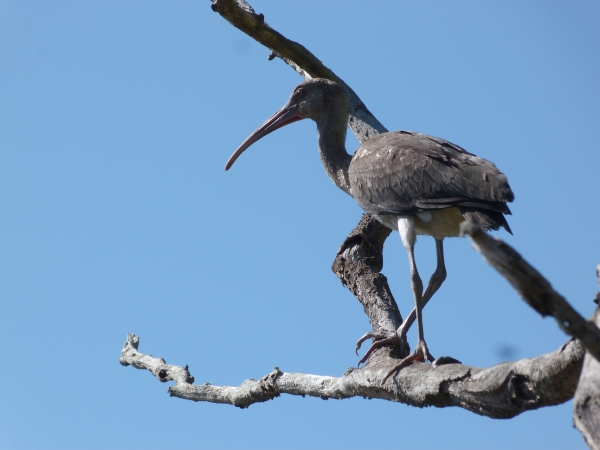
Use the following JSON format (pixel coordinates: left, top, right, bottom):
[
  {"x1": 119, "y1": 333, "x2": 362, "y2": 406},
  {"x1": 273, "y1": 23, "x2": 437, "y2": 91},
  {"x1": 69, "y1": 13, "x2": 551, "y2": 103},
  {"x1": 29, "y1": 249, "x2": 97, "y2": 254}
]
[{"x1": 120, "y1": 334, "x2": 583, "y2": 419}]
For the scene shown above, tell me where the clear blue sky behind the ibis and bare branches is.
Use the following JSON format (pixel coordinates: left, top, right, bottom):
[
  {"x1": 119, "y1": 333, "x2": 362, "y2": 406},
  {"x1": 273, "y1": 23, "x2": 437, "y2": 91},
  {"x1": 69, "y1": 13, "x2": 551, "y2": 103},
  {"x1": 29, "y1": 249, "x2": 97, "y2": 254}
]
[{"x1": 0, "y1": 0, "x2": 600, "y2": 449}]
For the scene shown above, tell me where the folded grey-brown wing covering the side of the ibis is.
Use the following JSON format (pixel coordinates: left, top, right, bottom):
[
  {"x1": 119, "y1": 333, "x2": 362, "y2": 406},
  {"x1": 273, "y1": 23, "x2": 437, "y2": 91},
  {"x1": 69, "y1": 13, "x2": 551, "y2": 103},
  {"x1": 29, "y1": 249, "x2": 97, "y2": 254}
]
[{"x1": 349, "y1": 131, "x2": 514, "y2": 214}]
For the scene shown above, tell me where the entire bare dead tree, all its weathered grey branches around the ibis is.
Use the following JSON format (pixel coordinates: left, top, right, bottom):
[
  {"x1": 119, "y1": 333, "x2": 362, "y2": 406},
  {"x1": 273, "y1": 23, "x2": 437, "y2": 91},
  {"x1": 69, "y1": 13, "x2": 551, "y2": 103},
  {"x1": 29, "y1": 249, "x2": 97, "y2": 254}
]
[{"x1": 120, "y1": 0, "x2": 600, "y2": 449}]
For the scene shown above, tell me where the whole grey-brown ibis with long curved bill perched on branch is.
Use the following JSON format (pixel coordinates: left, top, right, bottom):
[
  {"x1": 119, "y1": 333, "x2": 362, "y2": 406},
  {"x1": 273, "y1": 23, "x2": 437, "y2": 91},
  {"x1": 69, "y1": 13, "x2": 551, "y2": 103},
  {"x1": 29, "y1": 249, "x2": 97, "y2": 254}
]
[{"x1": 225, "y1": 78, "x2": 514, "y2": 381}]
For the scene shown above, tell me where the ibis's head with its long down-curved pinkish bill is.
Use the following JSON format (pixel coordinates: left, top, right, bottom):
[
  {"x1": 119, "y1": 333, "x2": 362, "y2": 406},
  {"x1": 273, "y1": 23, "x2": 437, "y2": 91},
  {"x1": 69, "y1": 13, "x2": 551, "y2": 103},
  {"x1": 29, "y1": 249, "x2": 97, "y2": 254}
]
[{"x1": 225, "y1": 78, "x2": 347, "y2": 170}]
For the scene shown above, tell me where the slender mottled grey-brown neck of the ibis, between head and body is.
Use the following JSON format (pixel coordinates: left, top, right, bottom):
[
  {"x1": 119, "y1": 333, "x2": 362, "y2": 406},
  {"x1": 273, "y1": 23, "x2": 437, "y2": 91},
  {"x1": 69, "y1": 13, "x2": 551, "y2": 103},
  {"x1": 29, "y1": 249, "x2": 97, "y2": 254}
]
[{"x1": 316, "y1": 110, "x2": 352, "y2": 195}]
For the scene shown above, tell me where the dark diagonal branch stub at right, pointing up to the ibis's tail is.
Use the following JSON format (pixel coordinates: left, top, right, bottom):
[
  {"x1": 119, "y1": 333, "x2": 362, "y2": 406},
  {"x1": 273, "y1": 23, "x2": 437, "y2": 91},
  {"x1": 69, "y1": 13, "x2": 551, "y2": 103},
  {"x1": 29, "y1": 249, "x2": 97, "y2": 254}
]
[{"x1": 463, "y1": 222, "x2": 600, "y2": 361}]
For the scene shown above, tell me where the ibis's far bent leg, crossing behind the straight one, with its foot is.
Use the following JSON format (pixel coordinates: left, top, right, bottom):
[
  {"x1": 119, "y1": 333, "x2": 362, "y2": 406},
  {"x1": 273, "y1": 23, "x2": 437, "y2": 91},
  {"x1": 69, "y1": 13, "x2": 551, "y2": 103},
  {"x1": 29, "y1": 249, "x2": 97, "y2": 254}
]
[{"x1": 356, "y1": 239, "x2": 446, "y2": 366}]
